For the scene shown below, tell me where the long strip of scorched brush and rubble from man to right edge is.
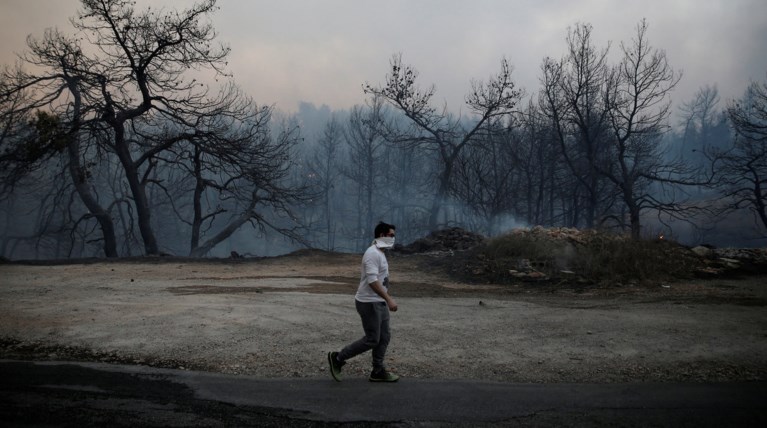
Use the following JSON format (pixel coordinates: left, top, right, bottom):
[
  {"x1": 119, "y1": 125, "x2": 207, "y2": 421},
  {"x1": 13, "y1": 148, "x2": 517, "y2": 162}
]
[{"x1": 397, "y1": 227, "x2": 767, "y2": 287}]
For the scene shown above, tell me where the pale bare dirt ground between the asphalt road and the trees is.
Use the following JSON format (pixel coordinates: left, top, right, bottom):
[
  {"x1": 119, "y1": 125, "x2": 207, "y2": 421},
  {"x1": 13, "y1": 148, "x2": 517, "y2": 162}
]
[{"x1": 0, "y1": 251, "x2": 767, "y2": 383}]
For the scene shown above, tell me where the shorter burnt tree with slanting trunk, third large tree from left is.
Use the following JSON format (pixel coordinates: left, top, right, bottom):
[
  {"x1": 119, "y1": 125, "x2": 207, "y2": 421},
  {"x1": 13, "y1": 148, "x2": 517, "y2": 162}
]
[{"x1": 155, "y1": 85, "x2": 306, "y2": 257}]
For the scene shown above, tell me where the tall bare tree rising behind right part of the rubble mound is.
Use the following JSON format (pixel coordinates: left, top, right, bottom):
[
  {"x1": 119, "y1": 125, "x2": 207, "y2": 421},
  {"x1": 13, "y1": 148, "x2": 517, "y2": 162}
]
[{"x1": 599, "y1": 20, "x2": 700, "y2": 239}]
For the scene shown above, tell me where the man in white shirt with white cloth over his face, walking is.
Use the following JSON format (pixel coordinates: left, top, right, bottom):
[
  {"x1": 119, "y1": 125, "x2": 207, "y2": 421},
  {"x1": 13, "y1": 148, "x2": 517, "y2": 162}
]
[{"x1": 328, "y1": 222, "x2": 399, "y2": 382}]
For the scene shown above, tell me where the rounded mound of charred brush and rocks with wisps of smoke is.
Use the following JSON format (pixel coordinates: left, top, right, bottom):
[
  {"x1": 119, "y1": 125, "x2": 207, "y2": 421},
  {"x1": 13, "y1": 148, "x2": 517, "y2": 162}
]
[{"x1": 454, "y1": 228, "x2": 700, "y2": 285}]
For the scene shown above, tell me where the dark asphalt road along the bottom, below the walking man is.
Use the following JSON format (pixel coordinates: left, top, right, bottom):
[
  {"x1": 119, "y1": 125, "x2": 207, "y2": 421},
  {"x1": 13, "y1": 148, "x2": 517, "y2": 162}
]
[{"x1": 0, "y1": 360, "x2": 767, "y2": 427}]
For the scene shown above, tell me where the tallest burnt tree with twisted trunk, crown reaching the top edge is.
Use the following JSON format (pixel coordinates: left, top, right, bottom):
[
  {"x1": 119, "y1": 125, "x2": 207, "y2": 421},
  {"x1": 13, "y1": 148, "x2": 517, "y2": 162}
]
[{"x1": 73, "y1": 0, "x2": 229, "y2": 254}]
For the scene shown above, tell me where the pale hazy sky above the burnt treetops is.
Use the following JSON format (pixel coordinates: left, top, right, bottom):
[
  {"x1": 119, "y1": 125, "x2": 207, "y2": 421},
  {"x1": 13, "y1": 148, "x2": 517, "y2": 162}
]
[{"x1": 0, "y1": 0, "x2": 767, "y2": 111}]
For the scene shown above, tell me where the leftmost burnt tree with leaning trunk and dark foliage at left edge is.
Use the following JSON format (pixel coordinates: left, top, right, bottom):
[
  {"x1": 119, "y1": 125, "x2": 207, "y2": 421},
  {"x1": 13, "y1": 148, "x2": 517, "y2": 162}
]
[{"x1": 0, "y1": 30, "x2": 117, "y2": 257}]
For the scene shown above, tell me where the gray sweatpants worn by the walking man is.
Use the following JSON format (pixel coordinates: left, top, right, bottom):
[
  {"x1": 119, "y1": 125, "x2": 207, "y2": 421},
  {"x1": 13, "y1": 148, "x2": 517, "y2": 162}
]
[{"x1": 338, "y1": 300, "x2": 391, "y2": 370}]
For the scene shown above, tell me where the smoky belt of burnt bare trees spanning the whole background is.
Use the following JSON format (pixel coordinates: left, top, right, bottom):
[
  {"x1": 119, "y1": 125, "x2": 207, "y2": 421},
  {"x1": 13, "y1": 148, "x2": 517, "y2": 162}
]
[{"x1": 0, "y1": 0, "x2": 767, "y2": 260}]
